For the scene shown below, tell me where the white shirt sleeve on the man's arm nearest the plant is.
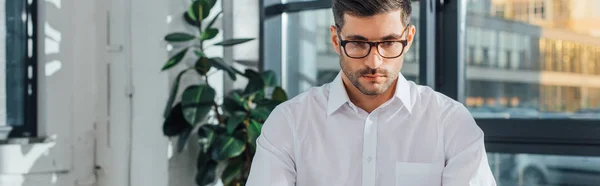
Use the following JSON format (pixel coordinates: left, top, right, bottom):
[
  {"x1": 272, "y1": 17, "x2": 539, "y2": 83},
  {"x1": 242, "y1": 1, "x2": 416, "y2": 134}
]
[{"x1": 246, "y1": 106, "x2": 296, "y2": 186}]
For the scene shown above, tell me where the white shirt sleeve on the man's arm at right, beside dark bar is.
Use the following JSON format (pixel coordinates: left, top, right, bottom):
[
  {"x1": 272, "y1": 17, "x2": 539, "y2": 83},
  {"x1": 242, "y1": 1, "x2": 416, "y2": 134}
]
[{"x1": 442, "y1": 104, "x2": 496, "y2": 186}]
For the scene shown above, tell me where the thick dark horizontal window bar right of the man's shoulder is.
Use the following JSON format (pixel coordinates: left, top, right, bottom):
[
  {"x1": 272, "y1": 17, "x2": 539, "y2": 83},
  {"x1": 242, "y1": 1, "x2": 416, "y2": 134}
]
[{"x1": 477, "y1": 119, "x2": 600, "y2": 156}]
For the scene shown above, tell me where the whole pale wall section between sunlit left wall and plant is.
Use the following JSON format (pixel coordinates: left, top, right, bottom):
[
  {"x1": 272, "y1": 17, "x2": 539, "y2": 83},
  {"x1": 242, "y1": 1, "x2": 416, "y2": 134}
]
[{"x1": 97, "y1": 0, "x2": 170, "y2": 186}]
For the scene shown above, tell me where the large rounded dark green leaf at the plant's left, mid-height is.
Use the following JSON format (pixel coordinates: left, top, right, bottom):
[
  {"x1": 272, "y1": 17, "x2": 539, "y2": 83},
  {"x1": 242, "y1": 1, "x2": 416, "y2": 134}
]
[{"x1": 181, "y1": 85, "x2": 216, "y2": 126}]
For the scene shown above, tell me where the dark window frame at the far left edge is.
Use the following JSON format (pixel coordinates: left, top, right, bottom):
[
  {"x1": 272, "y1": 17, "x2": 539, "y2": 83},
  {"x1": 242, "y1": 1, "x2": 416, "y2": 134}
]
[{"x1": 8, "y1": 0, "x2": 38, "y2": 138}]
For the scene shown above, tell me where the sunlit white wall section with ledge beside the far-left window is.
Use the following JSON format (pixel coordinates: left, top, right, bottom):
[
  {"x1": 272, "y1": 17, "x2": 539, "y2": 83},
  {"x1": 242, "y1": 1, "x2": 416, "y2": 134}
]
[{"x1": 0, "y1": 0, "x2": 98, "y2": 186}]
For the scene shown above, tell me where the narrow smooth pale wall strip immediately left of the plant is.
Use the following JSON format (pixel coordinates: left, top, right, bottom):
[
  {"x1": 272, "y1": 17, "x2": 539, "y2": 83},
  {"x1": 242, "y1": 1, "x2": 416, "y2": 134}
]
[{"x1": 129, "y1": 0, "x2": 170, "y2": 186}]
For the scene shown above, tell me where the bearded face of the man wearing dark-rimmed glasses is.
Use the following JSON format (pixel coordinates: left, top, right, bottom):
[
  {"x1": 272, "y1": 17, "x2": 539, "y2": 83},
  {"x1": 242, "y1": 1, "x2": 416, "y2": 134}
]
[{"x1": 330, "y1": 10, "x2": 415, "y2": 95}]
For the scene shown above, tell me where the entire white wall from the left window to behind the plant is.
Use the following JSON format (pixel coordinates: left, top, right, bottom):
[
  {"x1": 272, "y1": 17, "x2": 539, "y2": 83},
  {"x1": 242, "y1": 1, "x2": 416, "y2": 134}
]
[{"x1": 0, "y1": 0, "x2": 258, "y2": 186}]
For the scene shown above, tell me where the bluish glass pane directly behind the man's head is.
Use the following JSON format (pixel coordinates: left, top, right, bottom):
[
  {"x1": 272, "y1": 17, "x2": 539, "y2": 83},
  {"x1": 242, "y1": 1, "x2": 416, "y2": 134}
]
[{"x1": 282, "y1": 2, "x2": 419, "y2": 96}]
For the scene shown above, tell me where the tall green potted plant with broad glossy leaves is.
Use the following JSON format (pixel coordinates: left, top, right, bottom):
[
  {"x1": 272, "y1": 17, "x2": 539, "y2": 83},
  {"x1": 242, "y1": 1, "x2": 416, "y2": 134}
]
[{"x1": 162, "y1": 0, "x2": 287, "y2": 186}]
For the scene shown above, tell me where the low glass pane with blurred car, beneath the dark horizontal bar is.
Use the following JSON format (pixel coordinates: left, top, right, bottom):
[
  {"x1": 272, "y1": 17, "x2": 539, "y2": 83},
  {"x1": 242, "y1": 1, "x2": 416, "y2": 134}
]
[{"x1": 488, "y1": 153, "x2": 600, "y2": 186}]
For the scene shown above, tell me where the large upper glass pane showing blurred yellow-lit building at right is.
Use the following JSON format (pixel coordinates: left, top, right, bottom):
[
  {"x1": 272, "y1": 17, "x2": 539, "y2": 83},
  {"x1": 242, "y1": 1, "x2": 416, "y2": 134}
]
[{"x1": 465, "y1": 0, "x2": 600, "y2": 119}]
